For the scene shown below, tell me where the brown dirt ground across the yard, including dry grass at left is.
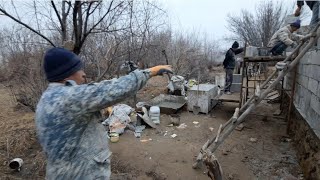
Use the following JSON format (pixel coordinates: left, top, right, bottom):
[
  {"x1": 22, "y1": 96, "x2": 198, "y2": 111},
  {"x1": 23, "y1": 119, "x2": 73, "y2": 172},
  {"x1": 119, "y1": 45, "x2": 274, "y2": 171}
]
[{"x1": 0, "y1": 77, "x2": 303, "y2": 180}]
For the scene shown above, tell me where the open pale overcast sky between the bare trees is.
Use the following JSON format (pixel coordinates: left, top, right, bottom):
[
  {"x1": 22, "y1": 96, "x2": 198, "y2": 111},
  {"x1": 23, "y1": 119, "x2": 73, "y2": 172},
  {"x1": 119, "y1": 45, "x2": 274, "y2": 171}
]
[{"x1": 160, "y1": 0, "x2": 309, "y2": 45}]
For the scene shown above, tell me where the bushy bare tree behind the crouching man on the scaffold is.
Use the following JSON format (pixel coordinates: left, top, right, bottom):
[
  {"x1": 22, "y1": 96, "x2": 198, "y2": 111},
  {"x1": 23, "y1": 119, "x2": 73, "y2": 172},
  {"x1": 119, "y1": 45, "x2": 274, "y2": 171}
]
[{"x1": 227, "y1": 0, "x2": 289, "y2": 47}]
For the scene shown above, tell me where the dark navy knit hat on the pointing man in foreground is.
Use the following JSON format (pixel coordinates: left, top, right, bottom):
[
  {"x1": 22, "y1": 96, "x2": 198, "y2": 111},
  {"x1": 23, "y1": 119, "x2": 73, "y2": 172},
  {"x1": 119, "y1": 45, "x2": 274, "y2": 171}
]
[{"x1": 44, "y1": 47, "x2": 82, "y2": 82}]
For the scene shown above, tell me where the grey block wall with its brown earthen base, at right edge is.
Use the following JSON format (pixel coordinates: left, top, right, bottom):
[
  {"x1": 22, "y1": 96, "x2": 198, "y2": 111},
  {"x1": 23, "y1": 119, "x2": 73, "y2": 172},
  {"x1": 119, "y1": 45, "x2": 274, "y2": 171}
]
[{"x1": 284, "y1": 50, "x2": 320, "y2": 179}]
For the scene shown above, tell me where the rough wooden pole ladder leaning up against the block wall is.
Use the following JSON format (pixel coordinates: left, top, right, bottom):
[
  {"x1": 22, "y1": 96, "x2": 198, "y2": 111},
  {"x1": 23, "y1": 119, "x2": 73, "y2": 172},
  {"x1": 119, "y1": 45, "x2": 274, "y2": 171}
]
[{"x1": 193, "y1": 23, "x2": 320, "y2": 180}]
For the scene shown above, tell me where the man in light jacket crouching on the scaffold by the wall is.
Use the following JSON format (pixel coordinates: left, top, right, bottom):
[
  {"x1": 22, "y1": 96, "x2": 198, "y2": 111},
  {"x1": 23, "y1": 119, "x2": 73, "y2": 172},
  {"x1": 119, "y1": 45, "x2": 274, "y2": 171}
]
[{"x1": 267, "y1": 20, "x2": 304, "y2": 56}]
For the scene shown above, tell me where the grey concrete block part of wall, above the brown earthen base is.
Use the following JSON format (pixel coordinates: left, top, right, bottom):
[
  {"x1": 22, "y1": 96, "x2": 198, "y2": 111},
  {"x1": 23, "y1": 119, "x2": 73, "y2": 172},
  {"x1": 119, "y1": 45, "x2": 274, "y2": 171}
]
[{"x1": 285, "y1": 50, "x2": 320, "y2": 138}]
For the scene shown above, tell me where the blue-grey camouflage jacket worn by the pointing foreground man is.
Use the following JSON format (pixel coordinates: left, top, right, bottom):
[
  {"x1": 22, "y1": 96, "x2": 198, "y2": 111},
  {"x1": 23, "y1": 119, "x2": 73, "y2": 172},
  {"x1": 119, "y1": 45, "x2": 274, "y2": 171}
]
[{"x1": 36, "y1": 70, "x2": 150, "y2": 180}]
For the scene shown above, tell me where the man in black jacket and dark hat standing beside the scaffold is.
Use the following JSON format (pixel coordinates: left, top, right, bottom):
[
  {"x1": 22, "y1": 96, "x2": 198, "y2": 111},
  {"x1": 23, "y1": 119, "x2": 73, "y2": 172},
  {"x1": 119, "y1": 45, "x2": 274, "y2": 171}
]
[{"x1": 223, "y1": 41, "x2": 244, "y2": 94}]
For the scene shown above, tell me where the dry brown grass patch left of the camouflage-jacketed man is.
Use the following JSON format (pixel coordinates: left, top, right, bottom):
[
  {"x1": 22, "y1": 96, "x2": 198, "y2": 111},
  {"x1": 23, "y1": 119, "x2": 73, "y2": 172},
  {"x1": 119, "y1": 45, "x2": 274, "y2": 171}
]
[{"x1": 0, "y1": 86, "x2": 45, "y2": 179}]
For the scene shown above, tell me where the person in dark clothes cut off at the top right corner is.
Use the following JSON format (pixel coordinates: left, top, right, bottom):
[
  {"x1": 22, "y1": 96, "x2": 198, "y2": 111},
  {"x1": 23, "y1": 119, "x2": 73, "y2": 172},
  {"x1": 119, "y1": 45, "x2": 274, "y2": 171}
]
[{"x1": 294, "y1": 0, "x2": 320, "y2": 28}]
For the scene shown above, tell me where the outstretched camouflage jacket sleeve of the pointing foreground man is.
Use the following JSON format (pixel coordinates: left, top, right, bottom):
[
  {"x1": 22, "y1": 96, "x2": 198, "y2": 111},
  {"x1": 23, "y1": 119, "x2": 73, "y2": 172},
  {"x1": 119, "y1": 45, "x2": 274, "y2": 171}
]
[{"x1": 64, "y1": 70, "x2": 150, "y2": 114}]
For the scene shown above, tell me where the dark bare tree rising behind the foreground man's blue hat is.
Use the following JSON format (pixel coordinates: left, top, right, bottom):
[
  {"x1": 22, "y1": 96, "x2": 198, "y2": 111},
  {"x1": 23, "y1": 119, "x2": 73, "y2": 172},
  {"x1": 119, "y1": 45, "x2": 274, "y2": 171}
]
[{"x1": 0, "y1": 0, "x2": 127, "y2": 54}]
